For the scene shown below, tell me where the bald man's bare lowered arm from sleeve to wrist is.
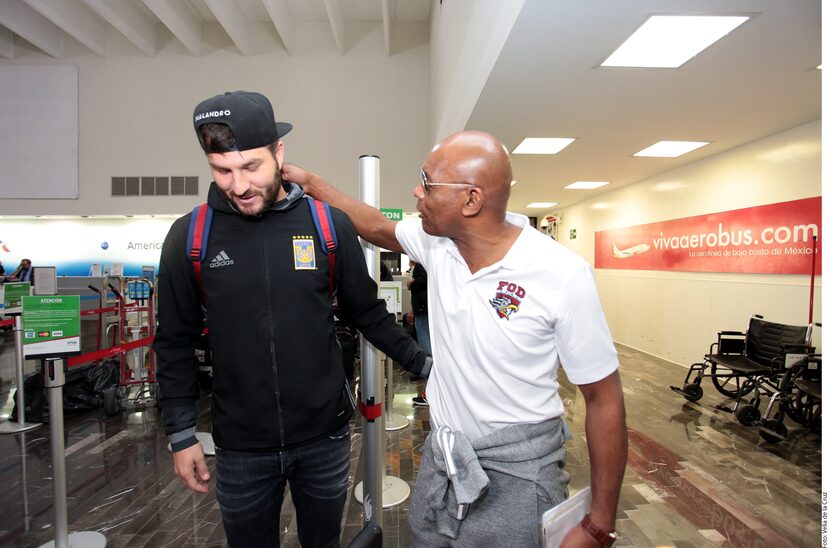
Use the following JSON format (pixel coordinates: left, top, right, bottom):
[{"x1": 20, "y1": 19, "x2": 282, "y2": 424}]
[{"x1": 585, "y1": 373, "x2": 628, "y2": 531}]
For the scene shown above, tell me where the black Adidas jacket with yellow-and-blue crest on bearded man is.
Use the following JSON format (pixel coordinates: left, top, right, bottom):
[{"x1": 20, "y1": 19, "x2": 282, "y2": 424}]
[{"x1": 153, "y1": 183, "x2": 428, "y2": 451}]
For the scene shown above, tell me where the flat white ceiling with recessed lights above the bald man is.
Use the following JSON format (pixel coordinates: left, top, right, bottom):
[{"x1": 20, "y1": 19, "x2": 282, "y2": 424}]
[{"x1": 472, "y1": 0, "x2": 821, "y2": 215}]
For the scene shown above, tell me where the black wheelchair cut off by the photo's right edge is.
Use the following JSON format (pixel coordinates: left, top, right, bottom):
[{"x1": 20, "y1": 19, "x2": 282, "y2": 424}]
[{"x1": 755, "y1": 354, "x2": 821, "y2": 443}]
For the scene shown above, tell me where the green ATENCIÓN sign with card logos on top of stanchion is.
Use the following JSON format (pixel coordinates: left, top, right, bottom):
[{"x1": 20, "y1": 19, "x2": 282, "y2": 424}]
[{"x1": 23, "y1": 295, "x2": 81, "y2": 358}]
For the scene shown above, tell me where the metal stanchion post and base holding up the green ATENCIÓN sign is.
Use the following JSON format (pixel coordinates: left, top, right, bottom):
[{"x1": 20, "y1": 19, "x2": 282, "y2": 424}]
[{"x1": 41, "y1": 358, "x2": 107, "y2": 548}]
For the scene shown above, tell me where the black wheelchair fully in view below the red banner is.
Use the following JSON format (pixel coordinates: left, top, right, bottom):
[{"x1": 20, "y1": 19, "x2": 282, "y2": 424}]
[{"x1": 670, "y1": 315, "x2": 812, "y2": 426}]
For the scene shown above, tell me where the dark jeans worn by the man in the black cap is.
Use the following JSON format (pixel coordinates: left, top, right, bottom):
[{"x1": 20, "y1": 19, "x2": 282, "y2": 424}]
[{"x1": 216, "y1": 424, "x2": 351, "y2": 548}]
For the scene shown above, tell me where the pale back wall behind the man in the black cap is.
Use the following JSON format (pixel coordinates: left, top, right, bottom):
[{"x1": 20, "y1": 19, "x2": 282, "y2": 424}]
[{"x1": 0, "y1": 22, "x2": 431, "y2": 215}]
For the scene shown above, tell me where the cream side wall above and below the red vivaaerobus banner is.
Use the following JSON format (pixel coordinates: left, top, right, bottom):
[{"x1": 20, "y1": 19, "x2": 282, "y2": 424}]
[{"x1": 556, "y1": 120, "x2": 821, "y2": 366}]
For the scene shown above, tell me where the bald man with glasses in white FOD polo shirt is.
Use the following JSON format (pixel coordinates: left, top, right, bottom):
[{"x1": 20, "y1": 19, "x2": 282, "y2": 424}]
[{"x1": 283, "y1": 131, "x2": 627, "y2": 547}]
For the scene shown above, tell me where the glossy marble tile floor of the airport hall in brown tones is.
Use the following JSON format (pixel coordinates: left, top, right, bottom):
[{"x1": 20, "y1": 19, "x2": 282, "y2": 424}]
[{"x1": 0, "y1": 337, "x2": 821, "y2": 548}]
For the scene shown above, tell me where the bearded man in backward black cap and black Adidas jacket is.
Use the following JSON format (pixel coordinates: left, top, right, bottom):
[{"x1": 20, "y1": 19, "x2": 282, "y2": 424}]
[{"x1": 154, "y1": 91, "x2": 432, "y2": 548}]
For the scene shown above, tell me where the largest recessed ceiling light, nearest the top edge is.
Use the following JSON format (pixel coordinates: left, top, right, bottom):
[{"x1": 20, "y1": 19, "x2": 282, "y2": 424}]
[{"x1": 601, "y1": 15, "x2": 749, "y2": 68}]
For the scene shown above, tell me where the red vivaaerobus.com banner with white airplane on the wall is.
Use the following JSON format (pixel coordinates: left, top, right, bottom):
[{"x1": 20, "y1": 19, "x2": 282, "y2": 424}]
[{"x1": 594, "y1": 196, "x2": 821, "y2": 274}]
